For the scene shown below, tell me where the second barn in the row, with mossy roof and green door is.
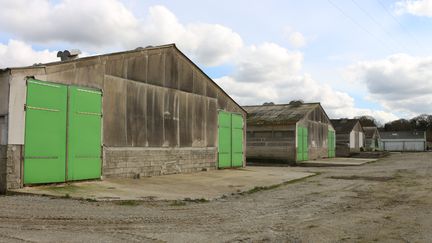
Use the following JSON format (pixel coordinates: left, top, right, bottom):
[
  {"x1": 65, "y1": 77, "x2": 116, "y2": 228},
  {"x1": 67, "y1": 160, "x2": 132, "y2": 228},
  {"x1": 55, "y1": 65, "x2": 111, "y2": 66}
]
[{"x1": 244, "y1": 103, "x2": 335, "y2": 163}]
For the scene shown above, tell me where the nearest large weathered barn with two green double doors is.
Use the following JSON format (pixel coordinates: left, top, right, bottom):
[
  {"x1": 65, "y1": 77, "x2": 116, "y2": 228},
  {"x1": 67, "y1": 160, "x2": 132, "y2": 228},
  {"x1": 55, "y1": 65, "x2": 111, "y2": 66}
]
[{"x1": 0, "y1": 44, "x2": 246, "y2": 192}]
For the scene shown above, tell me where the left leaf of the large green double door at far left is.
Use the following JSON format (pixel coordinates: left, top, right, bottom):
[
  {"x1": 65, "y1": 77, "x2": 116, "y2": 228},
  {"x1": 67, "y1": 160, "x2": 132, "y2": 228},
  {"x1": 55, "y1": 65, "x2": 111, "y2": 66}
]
[{"x1": 24, "y1": 79, "x2": 67, "y2": 184}]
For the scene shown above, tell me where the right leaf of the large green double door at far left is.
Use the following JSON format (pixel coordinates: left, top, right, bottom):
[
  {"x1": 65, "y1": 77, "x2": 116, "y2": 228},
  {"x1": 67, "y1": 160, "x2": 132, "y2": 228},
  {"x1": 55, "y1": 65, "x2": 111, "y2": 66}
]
[{"x1": 67, "y1": 86, "x2": 102, "y2": 181}]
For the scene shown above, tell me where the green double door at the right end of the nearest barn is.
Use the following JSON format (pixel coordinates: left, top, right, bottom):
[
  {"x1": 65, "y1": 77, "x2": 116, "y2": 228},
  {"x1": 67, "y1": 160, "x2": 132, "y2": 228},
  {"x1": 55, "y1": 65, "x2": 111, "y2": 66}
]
[{"x1": 218, "y1": 111, "x2": 244, "y2": 168}]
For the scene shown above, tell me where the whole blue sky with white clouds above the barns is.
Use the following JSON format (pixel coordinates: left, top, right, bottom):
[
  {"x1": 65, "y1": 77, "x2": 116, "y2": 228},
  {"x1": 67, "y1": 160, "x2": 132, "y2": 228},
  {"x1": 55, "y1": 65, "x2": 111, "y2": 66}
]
[{"x1": 0, "y1": 0, "x2": 432, "y2": 121}]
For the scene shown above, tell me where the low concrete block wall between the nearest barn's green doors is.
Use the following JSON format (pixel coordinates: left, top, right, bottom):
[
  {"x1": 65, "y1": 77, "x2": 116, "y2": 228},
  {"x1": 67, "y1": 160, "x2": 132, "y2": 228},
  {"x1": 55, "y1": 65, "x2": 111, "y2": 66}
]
[{"x1": 102, "y1": 147, "x2": 217, "y2": 178}]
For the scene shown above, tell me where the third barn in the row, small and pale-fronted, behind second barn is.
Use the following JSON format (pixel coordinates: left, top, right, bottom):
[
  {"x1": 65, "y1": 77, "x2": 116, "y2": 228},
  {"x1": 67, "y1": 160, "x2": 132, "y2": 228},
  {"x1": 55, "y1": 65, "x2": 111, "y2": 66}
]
[{"x1": 331, "y1": 118, "x2": 365, "y2": 157}]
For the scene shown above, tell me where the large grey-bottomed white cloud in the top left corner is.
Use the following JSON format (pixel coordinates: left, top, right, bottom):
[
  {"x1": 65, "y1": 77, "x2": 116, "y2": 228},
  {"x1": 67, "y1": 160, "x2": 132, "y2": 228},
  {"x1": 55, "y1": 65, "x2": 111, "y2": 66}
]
[{"x1": 0, "y1": 0, "x2": 139, "y2": 46}]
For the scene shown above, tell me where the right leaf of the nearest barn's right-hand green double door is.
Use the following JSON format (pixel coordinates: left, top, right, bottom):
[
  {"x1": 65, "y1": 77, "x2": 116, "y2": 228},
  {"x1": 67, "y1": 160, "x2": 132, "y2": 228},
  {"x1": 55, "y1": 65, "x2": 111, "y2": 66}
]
[{"x1": 231, "y1": 114, "x2": 243, "y2": 167}]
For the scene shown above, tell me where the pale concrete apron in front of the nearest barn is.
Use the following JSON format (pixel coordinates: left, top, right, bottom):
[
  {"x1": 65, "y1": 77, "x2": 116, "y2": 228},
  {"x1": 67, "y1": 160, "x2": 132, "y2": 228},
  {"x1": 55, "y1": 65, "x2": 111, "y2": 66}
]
[{"x1": 12, "y1": 166, "x2": 314, "y2": 201}]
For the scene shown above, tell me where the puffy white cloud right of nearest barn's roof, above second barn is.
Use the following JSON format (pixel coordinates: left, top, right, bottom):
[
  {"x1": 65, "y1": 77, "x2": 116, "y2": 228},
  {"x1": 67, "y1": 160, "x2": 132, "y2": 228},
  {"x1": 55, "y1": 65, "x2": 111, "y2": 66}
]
[{"x1": 215, "y1": 43, "x2": 397, "y2": 122}]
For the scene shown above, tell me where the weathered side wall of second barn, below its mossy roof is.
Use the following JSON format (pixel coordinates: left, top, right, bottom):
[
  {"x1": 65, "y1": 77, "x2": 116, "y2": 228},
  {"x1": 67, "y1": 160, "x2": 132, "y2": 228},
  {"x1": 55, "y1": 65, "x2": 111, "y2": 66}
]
[{"x1": 246, "y1": 125, "x2": 296, "y2": 162}]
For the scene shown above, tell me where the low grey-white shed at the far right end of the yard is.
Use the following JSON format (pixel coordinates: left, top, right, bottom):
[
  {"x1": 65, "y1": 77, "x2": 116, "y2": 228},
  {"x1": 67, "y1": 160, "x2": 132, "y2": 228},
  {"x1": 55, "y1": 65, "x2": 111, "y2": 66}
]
[{"x1": 380, "y1": 131, "x2": 426, "y2": 152}]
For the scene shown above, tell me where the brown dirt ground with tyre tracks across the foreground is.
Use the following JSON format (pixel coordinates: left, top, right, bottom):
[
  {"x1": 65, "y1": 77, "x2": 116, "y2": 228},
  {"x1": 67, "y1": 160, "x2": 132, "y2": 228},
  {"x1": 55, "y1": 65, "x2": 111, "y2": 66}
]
[{"x1": 0, "y1": 153, "x2": 432, "y2": 242}]
